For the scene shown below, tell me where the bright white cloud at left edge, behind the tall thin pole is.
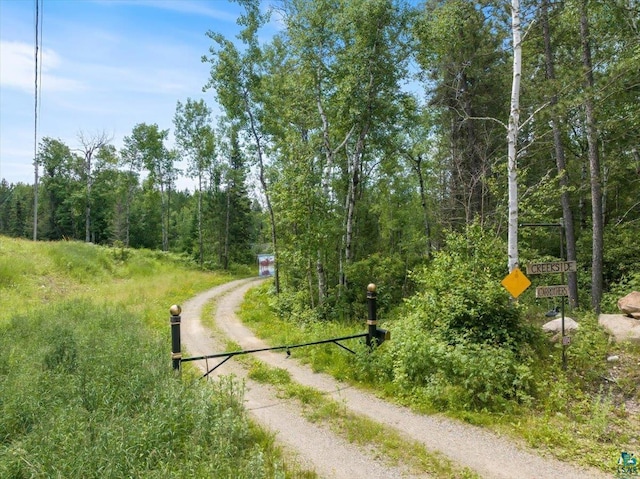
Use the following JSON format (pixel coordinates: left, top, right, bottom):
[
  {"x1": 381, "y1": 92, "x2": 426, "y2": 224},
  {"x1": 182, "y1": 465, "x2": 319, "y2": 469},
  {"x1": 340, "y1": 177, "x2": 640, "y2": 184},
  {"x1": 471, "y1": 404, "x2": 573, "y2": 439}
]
[{"x1": 0, "y1": 40, "x2": 83, "y2": 92}]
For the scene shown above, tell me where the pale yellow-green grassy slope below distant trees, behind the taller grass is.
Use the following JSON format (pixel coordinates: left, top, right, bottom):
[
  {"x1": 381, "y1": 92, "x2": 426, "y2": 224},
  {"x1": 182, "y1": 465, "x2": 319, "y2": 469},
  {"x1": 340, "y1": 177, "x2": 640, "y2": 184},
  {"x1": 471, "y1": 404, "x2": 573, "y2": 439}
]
[{"x1": 0, "y1": 237, "x2": 225, "y2": 324}]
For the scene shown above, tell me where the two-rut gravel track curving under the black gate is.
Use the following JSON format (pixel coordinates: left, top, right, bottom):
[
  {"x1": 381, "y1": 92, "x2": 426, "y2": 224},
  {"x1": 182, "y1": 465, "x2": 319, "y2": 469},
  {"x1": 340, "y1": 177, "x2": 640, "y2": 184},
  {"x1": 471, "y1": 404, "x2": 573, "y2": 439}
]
[{"x1": 182, "y1": 279, "x2": 612, "y2": 479}]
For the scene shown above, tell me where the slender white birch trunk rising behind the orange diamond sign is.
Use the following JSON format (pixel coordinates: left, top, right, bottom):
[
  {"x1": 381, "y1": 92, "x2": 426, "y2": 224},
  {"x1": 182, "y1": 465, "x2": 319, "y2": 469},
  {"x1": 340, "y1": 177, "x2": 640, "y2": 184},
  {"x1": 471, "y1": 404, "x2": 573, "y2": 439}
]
[{"x1": 507, "y1": 0, "x2": 522, "y2": 271}]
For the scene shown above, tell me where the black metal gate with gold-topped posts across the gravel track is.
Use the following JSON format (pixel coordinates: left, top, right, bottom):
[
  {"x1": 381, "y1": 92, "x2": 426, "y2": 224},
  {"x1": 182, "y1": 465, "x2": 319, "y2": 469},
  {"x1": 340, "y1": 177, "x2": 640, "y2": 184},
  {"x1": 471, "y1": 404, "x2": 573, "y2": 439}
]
[{"x1": 169, "y1": 283, "x2": 390, "y2": 378}]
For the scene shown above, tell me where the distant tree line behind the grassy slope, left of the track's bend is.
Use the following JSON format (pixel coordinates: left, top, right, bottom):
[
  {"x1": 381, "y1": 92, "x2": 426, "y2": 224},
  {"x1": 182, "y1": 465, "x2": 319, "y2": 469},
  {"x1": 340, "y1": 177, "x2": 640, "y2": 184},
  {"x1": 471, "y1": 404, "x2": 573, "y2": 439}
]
[{"x1": 0, "y1": 116, "x2": 261, "y2": 269}]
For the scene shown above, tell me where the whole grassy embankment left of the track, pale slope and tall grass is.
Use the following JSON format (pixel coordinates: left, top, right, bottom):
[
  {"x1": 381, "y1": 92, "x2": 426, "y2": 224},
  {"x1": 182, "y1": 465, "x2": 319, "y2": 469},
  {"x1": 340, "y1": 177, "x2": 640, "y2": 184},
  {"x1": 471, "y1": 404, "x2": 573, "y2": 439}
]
[{"x1": 0, "y1": 237, "x2": 315, "y2": 479}]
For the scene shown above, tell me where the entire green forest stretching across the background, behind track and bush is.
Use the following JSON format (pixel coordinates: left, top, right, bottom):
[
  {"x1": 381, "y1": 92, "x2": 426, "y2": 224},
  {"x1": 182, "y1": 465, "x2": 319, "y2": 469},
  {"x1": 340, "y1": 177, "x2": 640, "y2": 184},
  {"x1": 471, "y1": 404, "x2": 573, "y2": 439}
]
[{"x1": 0, "y1": 0, "x2": 640, "y2": 319}]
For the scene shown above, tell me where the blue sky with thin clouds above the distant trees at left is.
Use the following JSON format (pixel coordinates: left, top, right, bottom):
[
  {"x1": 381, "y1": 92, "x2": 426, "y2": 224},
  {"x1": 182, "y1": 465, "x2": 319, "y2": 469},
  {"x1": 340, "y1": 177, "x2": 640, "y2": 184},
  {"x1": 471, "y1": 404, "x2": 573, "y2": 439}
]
[{"x1": 0, "y1": 0, "x2": 276, "y2": 187}]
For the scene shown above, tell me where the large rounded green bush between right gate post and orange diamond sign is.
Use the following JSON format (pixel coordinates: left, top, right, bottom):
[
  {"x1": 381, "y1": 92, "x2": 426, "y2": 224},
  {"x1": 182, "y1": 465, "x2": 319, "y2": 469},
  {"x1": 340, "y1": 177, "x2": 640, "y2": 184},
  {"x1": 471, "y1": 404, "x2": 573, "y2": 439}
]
[{"x1": 376, "y1": 225, "x2": 539, "y2": 411}]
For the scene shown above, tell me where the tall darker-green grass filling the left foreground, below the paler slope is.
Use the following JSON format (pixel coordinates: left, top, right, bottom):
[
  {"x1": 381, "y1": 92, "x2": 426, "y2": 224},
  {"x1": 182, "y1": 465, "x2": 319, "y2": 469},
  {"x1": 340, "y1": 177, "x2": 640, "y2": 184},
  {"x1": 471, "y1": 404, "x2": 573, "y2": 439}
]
[{"x1": 0, "y1": 300, "x2": 278, "y2": 478}]
